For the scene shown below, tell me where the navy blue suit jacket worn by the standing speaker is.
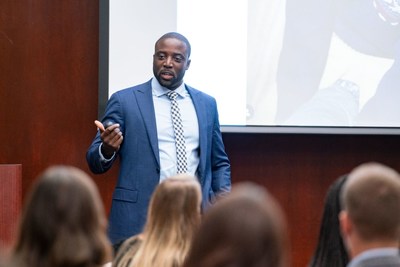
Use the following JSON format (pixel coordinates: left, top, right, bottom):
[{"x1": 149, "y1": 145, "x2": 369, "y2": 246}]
[{"x1": 86, "y1": 80, "x2": 231, "y2": 243}]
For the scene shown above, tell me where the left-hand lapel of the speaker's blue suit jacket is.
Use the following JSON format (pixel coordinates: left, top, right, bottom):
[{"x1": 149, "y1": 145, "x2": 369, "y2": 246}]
[{"x1": 135, "y1": 80, "x2": 160, "y2": 166}]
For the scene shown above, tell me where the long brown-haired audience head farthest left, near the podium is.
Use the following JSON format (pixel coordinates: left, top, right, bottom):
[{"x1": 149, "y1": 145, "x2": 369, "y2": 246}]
[{"x1": 10, "y1": 166, "x2": 111, "y2": 267}]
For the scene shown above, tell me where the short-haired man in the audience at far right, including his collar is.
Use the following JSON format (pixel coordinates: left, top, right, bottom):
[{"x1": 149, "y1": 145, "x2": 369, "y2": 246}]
[{"x1": 340, "y1": 163, "x2": 400, "y2": 267}]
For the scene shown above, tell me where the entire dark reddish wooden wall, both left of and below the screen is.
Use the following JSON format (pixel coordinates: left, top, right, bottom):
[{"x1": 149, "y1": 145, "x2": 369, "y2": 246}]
[{"x1": 0, "y1": 0, "x2": 400, "y2": 267}]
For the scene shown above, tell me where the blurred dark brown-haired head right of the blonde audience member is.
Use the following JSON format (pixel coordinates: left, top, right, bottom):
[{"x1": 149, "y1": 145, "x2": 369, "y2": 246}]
[{"x1": 185, "y1": 182, "x2": 289, "y2": 267}]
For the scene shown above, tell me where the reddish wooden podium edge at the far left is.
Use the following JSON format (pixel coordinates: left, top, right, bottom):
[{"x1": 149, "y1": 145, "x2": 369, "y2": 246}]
[{"x1": 0, "y1": 164, "x2": 22, "y2": 249}]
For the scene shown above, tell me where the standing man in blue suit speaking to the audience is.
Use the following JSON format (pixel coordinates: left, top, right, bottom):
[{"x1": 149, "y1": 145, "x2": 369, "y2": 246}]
[{"x1": 86, "y1": 32, "x2": 231, "y2": 247}]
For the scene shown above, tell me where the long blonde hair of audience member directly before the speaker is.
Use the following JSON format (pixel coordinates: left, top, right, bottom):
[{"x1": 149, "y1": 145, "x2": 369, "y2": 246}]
[{"x1": 131, "y1": 174, "x2": 201, "y2": 267}]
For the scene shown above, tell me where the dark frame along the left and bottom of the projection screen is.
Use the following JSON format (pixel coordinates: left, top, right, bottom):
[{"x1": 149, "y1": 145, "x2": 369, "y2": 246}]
[{"x1": 97, "y1": 0, "x2": 400, "y2": 135}]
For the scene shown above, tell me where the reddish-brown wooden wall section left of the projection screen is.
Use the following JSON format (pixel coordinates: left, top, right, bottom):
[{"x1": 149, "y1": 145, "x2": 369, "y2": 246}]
[{"x1": 0, "y1": 0, "x2": 116, "y2": 248}]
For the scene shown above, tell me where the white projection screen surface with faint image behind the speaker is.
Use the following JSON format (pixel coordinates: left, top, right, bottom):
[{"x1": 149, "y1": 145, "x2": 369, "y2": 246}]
[{"x1": 109, "y1": 0, "x2": 400, "y2": 130}]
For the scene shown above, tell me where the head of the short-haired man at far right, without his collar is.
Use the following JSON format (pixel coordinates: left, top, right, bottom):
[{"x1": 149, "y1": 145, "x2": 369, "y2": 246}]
[{"x1": 340, "y1": 162, "x2": 400, "y2": 256}]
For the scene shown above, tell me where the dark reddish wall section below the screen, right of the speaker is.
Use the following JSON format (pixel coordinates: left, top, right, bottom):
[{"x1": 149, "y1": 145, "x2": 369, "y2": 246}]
[{"x1": 224, "y1": 133, "x2": 400, "y2": 267}]
